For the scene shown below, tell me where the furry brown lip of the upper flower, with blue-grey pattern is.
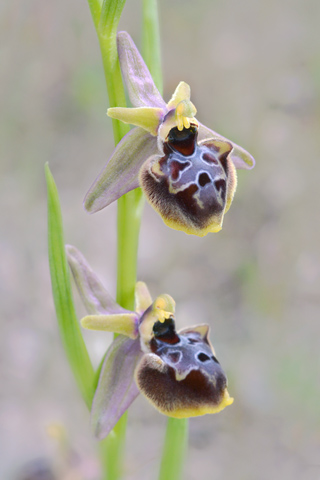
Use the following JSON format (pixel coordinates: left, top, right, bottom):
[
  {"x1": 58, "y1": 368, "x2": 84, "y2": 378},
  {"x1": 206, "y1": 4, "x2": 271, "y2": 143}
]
[{"x1": 140, "y1": 125, "x2": 237, "y2": 236}]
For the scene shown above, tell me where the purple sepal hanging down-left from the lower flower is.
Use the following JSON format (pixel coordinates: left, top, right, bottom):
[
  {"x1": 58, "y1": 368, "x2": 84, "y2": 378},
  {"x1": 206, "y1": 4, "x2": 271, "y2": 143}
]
[{"x1": 91, "y1": 335, "x2": 142, "y2": 440}]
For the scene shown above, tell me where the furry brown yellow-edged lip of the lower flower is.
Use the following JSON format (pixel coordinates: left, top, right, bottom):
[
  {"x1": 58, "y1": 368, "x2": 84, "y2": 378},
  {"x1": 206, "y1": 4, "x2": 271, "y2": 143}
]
[{"x1": 135, "y1": 317, "x2": 233, "y2": 418}]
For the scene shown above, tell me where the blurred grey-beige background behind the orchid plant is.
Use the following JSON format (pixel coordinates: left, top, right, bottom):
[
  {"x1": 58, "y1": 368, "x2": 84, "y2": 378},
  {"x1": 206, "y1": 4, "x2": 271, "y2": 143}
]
[{"x1": 0, "y1": 0, "x2": 320, "y2": 480}]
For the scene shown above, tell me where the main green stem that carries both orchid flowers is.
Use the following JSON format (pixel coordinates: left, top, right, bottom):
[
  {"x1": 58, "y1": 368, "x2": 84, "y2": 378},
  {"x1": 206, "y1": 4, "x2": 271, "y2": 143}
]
[{"x1": 88, "y1": 0, "x2": 142, "y2": 480}]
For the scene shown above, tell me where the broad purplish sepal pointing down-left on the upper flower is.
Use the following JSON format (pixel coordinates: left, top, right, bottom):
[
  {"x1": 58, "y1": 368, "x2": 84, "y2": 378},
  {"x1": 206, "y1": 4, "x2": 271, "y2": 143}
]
[{"x1": 84, "y1": 127, "x2": 158, "y2": 213}]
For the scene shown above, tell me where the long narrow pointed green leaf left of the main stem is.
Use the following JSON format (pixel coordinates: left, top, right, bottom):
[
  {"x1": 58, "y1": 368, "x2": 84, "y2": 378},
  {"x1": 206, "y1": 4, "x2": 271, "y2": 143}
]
[{"x1": 45, "y1": 164, "x2": 95, "y2": 408}]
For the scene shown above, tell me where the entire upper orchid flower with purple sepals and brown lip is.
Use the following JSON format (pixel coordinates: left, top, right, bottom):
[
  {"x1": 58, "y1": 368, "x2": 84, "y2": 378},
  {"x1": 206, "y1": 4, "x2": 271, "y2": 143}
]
[{"x1": 85, "y1": 32, "x2": 255, "y2": 236}]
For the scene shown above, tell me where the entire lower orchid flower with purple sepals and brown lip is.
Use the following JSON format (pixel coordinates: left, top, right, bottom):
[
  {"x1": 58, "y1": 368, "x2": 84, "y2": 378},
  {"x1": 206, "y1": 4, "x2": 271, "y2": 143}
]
[{"x1": 66, "y1": 246, "x2": 233, "y2": 439}]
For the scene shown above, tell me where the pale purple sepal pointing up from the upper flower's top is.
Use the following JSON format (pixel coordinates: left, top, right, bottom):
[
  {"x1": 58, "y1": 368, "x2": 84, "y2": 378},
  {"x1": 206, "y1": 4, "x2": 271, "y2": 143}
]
[{"x1": 117, "y1": 32, "x2": 166, "y2": 110}]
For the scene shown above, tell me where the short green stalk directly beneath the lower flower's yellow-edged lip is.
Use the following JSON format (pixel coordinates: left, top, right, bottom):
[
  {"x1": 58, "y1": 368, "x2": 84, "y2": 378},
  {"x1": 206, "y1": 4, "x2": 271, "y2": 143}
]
[{"x1": 159, "y1": 418, "x2": 188, "y2": 480}]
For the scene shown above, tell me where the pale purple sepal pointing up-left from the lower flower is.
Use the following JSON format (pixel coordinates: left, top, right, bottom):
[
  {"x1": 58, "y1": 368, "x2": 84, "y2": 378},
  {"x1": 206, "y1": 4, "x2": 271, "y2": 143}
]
[{"x1": 66, "y1": 245, "x2": 131, "y2": 314}]
